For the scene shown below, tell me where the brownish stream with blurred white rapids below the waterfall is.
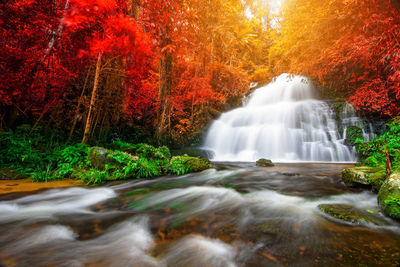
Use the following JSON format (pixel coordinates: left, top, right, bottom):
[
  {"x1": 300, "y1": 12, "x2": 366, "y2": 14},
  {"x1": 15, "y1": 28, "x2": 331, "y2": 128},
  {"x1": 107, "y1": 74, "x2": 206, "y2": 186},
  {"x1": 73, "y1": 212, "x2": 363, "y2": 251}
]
[{"x1": 0, "y1": 163, "x2": 400, "y2": 267}]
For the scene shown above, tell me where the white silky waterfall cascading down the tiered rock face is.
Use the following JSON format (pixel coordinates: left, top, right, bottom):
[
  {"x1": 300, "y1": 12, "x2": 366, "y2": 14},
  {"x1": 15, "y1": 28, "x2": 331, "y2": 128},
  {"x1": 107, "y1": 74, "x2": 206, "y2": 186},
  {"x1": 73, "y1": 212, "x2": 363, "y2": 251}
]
[{"x1": 204, "y1": 74, "x2": 364, "y2": 162}]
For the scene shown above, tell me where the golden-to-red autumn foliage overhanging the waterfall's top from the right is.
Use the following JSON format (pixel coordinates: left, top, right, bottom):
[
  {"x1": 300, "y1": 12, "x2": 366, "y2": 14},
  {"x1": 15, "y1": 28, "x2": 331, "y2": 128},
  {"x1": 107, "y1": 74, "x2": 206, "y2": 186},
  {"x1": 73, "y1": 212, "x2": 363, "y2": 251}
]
[{"x1": 270, "y1": 0, "x2": 400, "y2": 117}]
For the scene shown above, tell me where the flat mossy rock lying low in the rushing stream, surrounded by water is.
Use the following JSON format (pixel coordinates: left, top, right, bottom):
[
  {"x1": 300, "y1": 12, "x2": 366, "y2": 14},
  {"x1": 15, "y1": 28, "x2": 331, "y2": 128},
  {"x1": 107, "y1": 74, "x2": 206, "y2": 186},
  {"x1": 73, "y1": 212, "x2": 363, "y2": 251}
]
[{"x1": 318, "y1": 204, "x2": 387, "y2": 225}]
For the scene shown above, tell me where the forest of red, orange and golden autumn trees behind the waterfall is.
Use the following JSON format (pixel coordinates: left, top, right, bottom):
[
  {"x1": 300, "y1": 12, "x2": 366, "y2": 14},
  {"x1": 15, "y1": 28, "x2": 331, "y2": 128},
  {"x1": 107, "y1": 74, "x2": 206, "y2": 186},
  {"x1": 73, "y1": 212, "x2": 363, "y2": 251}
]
[{"x1": 0, "y1": 0, "x2": 400, "y2": 182}]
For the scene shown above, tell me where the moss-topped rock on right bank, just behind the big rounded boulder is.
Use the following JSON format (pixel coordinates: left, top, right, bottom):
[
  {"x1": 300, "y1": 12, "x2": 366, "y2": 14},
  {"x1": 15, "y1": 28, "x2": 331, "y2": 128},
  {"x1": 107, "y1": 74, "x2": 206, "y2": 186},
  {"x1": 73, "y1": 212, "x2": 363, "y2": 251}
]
[{"x1": 342, "y1": 166, "x2": 380, "y2": 186}]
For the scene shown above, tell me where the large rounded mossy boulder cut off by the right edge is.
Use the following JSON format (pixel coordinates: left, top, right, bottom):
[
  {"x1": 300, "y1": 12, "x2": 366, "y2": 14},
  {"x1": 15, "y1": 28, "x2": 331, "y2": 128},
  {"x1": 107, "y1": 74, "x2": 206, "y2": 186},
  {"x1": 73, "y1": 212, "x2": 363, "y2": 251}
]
[{"x1": 378, "y1": 173, "x2": 400, "y2": 219}]
